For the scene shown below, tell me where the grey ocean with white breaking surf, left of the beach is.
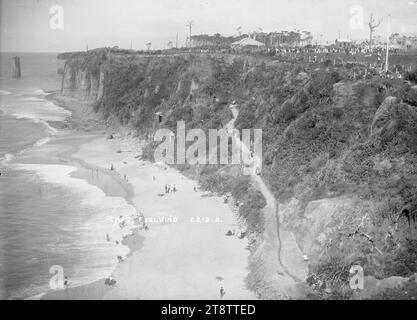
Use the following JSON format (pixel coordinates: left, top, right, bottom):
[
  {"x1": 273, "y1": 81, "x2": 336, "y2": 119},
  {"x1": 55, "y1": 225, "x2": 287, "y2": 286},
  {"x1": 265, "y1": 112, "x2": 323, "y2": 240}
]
[{"x1": 0, "y1": 53, "x2": 135, "y2": 299}]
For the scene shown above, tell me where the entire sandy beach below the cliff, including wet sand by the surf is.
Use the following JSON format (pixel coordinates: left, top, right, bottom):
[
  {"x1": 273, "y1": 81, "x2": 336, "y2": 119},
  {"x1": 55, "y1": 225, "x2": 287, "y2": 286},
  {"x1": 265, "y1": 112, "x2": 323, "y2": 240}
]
[{"x1": 35, "y1": 94, "x2": 255, "y2": 299}]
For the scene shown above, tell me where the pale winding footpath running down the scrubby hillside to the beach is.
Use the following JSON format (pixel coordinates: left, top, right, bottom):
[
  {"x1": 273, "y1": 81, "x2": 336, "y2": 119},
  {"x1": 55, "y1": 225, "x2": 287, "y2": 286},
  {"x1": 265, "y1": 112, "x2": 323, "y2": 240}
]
[{"x1": 225, "y1": 104, "x2": 307, "y2": 297}]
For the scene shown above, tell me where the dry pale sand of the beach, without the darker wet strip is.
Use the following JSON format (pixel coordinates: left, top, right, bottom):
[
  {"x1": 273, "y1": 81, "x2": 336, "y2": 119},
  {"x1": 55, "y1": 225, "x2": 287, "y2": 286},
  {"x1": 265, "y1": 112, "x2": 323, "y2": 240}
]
[{"x1": 74, "y1": 137, "x2": 253, "y2": 299}]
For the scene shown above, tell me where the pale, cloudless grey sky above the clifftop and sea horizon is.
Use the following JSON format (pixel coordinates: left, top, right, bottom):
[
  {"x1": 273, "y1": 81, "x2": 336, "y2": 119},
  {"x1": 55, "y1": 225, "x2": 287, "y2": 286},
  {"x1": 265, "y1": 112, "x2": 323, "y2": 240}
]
[{"x1": 0, "y1": 0, "x2": 417, "y2": 52}]
